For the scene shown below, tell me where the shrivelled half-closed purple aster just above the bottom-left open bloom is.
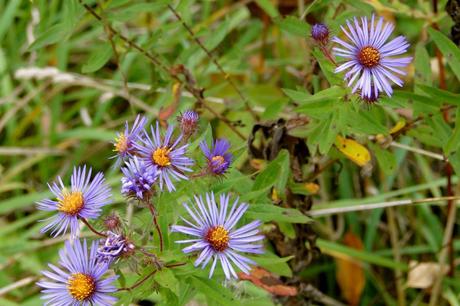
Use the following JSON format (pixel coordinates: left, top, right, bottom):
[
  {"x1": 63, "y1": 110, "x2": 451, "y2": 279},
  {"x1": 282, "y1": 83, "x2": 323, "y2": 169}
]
[{"x1": 97, "y1": 231, "x2": 134, "y2": 264}]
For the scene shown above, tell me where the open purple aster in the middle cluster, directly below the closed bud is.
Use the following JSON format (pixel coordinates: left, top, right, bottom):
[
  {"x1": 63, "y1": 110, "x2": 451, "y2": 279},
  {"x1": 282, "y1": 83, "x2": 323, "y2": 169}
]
[{"x1": 135, "y1": 122, "x2": 193, "y2": 191}]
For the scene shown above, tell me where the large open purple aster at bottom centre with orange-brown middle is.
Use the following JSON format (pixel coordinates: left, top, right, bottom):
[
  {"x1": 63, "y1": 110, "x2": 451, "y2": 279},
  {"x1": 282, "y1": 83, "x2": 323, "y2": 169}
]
[{"x1": 172, "y1": 193, "x2": 264, "y2": 279}]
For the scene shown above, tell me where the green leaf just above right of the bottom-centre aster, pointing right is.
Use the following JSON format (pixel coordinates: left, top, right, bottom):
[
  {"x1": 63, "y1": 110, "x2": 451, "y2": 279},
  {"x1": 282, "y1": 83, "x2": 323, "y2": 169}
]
[{"x1": 246, "y1": 204, "x2": 312, "y2": 223}]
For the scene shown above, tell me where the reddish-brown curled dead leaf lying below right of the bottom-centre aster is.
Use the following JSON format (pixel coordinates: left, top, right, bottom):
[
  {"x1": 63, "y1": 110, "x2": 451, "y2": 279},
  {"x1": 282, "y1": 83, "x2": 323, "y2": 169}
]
[{"x1": 238, "y1": 267, "x2": 297, "y2": 296}]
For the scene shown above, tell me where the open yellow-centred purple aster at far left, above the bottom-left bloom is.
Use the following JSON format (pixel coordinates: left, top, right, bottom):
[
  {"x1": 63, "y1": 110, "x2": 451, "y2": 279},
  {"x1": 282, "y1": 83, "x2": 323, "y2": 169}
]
[{"x1": 37, "y1": 166, "x2": 111, "y2": 237}]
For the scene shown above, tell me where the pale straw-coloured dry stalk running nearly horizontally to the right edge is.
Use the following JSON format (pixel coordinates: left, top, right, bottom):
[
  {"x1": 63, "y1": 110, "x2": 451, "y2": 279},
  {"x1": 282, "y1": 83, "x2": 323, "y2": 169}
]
[{"x1": 308, "y1": 196, "x2": 460, "y2": 217}]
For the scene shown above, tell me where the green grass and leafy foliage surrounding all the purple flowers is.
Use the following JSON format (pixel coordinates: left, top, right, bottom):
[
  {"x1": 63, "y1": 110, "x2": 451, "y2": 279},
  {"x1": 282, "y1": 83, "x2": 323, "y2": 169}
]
[{"x1": 0, "y1": 0, "x2": 460, "y2": 306}]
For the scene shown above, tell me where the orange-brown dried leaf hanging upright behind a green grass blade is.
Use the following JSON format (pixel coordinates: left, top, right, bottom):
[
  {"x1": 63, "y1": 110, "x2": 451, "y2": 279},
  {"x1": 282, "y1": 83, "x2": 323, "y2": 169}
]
[{"x1": 336, "y1": 232, "x2": 366, "y2": 305}]
